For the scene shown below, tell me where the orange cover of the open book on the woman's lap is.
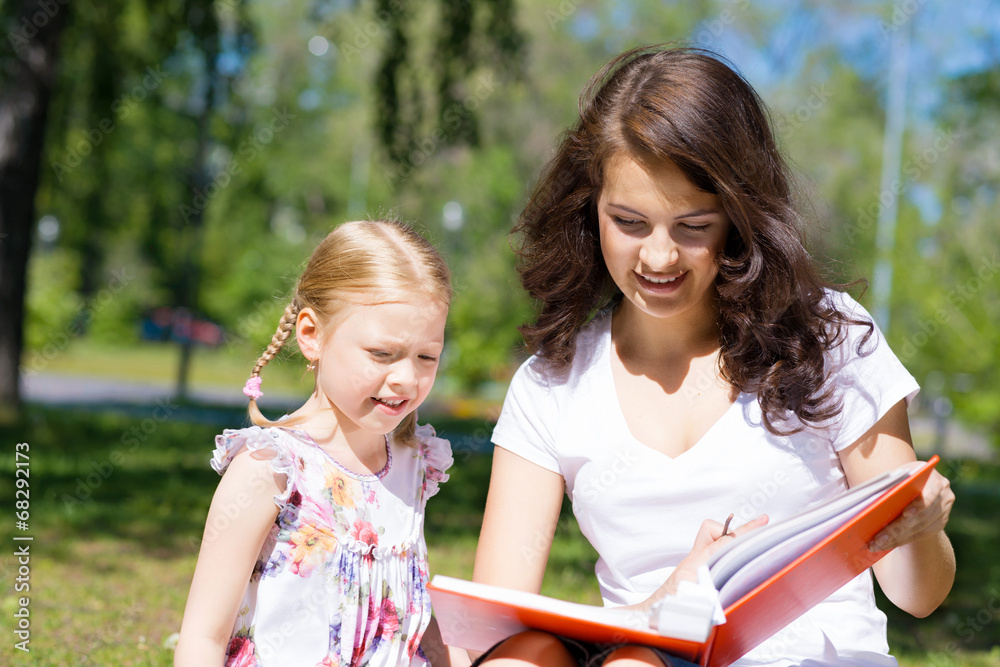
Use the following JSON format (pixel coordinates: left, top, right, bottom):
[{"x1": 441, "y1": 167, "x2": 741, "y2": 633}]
[{"x1": 428, "y1": 456, "x2": 939, "y2": 667}]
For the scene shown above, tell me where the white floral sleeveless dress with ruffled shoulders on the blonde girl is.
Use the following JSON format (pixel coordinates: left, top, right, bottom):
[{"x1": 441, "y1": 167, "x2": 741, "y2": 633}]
[{"x1": 212, "y1": 426, "x2": 452, "y2": 667}]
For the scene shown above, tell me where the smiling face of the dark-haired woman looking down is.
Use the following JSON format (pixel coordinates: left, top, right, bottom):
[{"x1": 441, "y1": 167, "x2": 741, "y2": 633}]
[{"x1": 597, "y1": 156, "x2": 730, "y2": 318}]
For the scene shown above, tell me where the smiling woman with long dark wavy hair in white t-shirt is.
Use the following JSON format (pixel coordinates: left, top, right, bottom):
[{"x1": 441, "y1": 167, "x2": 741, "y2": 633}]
[{"x1": 474, "y1": 47, "x2": 955, "y2": 667}]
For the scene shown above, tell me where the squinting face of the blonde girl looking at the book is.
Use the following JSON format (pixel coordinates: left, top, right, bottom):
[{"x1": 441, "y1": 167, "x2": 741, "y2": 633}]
[{"x1": 299, "y1": 297, "x2": 448, "y2": 434}]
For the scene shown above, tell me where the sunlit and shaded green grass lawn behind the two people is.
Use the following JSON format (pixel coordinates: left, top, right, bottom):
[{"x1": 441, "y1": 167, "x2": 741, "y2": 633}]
[{"x1": 0, "y1": 408, "x2": 1000, "y2": 667}]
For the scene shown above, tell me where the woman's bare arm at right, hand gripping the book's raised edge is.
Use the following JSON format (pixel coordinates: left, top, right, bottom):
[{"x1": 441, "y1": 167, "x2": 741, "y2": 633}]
[{"x1": 840, "y1": 401, "x2": 955, "y2": 618}]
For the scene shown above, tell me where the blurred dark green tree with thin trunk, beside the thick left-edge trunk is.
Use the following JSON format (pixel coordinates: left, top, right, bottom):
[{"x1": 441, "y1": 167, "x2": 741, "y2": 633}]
[{"x1": 21, "y1": 0, "x2": 252, "y2": 402}]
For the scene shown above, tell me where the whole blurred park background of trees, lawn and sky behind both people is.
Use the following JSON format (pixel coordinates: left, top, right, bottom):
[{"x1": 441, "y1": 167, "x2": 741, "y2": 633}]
[{"x1": 0, "y1": 0, "x2": 1000, "y2": 666}]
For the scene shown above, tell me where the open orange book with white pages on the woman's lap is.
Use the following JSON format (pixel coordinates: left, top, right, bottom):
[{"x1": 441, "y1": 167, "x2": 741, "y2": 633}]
[{"x1": 428, "y1": 456, "x2": 938, "y2": 667}]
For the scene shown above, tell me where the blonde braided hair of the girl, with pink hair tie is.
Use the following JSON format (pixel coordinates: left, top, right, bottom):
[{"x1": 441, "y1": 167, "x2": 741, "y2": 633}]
[{"x1": 248, "y1": 220, "x2": 452, "y2": 445}]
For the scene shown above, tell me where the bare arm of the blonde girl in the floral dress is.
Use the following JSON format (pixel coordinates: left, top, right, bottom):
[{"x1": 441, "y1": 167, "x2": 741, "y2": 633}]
[{"x1": 174, "y1": 451, "x2": 284, "y2": 667}]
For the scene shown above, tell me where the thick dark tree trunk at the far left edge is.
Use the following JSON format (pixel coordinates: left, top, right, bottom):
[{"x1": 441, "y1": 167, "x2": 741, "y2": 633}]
[{"x1": 0, "y1": 0, "x2": 69, "y2": 421}]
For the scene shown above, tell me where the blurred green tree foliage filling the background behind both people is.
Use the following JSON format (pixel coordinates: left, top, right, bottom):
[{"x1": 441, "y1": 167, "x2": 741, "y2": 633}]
[{"x1": 19, "y1": 0, "x2": 1000, "y2": 440}]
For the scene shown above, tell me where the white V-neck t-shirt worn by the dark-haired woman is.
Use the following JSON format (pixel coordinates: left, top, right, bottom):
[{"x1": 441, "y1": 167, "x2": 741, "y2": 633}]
[{"x1": 493, "y1": 292, "x2": 919, "y2": 667}]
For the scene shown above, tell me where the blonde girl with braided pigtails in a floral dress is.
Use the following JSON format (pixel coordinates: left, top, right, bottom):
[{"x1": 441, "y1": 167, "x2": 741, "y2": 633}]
[{"x1": 175, "y1": 221, "x2": 452, "y2": 667}]
